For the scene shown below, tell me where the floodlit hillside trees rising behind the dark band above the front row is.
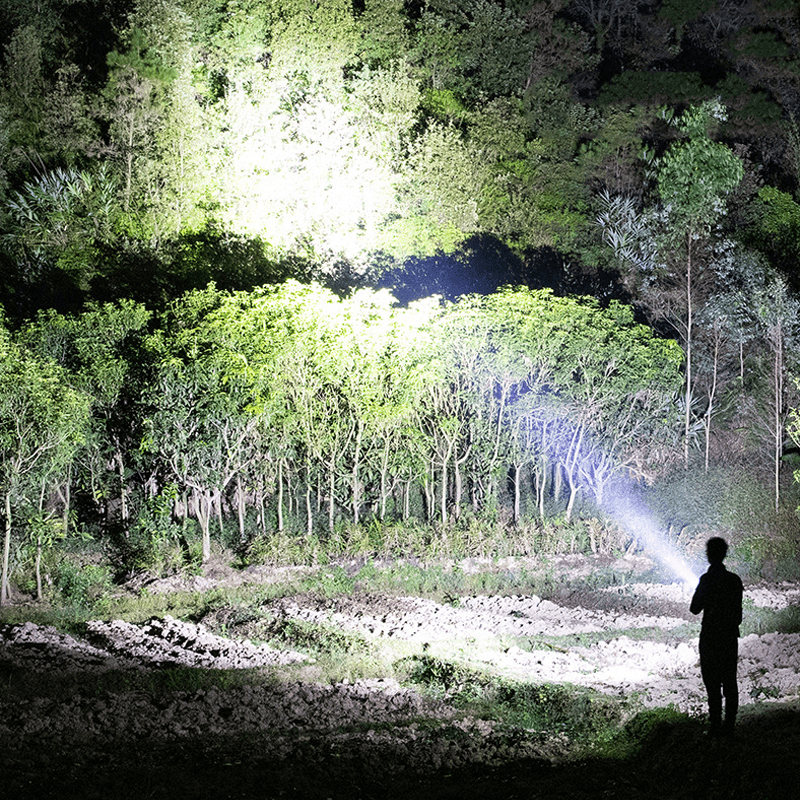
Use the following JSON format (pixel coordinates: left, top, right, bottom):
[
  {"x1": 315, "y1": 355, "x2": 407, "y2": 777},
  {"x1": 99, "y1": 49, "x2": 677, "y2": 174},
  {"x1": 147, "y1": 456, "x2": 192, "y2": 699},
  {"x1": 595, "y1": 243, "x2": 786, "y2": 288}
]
[{"x1": 0, "y1": 0, "x2": 800, "y2": 304}]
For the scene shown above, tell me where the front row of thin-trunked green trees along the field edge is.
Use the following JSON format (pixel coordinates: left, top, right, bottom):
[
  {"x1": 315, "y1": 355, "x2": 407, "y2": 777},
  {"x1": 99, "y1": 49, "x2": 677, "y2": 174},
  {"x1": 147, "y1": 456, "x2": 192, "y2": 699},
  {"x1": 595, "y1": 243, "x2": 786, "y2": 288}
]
[{"x1": 3, "y1": 282, "x2": 683, "y2": 576}]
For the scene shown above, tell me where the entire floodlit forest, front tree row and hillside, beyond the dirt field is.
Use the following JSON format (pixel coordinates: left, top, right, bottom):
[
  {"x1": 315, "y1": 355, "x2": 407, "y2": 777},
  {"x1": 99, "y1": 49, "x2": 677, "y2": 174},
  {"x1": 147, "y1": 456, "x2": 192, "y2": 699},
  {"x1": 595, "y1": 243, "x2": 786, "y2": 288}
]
[{"x1": 0, "y1": 0, "x2": 800, "y2": 602}]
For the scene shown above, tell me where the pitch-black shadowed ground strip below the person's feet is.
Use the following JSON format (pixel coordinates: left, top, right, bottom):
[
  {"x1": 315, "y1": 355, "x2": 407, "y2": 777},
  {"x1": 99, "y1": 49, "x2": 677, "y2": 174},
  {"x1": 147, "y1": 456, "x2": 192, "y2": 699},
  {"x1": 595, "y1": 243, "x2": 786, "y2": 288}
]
[{"x1": 0, "y1": 702, "x2": 800, "y2": 800}]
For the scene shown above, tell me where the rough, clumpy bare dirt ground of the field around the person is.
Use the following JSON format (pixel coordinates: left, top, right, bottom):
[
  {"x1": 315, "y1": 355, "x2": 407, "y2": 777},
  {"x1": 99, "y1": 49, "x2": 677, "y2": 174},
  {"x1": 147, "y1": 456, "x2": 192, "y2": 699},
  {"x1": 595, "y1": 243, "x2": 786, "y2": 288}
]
[{"x1": 0, "y1": 559, "x2": 800, "y2": 800}]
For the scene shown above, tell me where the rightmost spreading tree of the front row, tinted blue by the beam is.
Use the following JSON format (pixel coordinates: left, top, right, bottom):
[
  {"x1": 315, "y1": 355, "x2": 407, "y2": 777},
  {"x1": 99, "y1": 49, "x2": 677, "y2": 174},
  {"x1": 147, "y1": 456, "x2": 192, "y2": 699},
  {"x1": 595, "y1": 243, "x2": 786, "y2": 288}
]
[{"x1": 490, "y1": 289, "x2": 682, "y2": 515}]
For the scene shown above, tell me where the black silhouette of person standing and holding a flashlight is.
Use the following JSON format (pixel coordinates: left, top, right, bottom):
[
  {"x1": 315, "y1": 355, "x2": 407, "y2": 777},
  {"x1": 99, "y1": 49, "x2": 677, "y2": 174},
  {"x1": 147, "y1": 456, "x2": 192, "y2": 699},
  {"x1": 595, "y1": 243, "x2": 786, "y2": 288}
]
[{"x1": 689, "y1": 536, "x2": 744, "y2": 736}]
